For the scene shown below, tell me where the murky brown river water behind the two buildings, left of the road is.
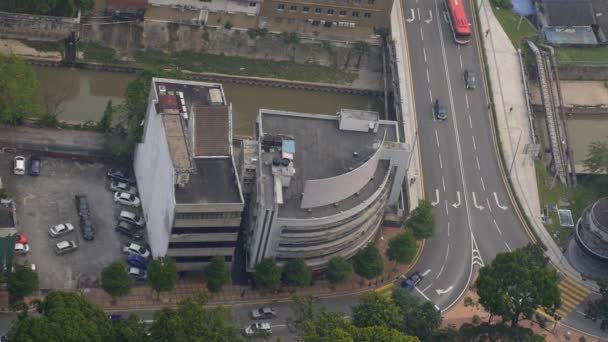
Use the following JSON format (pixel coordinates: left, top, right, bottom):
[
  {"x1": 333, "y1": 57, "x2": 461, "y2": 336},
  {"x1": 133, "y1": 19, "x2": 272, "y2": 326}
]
[{"x1": 34, "y1": 67, "x2": 384, "y2": 135}]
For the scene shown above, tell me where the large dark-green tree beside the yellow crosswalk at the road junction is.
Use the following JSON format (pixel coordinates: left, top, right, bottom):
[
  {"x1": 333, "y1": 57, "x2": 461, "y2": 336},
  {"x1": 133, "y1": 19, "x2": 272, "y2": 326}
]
[{"x1": 475, "y1": 244, "x2": 560, "y2": 327}]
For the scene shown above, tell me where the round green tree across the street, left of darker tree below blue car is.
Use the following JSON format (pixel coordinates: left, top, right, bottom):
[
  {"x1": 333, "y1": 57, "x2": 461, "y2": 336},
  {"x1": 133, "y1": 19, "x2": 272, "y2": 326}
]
[{"x1": 352, "y1": 291, "x2": 403, "y2": 329}]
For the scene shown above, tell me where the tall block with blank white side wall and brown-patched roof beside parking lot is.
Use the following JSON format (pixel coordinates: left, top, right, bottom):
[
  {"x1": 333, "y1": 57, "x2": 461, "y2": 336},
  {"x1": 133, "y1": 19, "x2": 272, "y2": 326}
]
[{"x1": 134, "y1": 78, "x2": 244, "y2": 271}]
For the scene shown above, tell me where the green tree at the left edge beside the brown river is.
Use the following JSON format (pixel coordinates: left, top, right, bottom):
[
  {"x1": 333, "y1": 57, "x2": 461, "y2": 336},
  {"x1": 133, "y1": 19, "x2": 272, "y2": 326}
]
[{"x1": 0, "y1": 54, "x2": 44, "y2": 125}]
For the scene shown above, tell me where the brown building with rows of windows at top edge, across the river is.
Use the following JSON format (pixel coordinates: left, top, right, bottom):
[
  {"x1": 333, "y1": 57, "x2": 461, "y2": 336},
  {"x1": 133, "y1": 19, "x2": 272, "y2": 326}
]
[{"x1": 259, "y1": 0, "x2": 393, "y2": 40}]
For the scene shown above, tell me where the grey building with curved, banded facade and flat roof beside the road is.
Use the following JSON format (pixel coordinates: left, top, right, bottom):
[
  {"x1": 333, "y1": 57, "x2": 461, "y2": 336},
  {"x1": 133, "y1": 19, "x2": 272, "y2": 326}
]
[{"x1": 247, "y1": 109, "x2": 409, "y2": 270}]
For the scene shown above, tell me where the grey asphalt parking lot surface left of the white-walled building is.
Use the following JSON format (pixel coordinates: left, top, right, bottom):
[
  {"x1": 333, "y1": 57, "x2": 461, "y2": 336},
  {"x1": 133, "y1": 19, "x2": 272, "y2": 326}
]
[{"x1": 0, "y1": 152, "x2": 142, "y2": 289}]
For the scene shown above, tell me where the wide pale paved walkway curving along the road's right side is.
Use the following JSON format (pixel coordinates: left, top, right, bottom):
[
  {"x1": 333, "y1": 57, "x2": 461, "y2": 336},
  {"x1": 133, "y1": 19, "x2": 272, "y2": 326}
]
[{"x1": 479, "y1": 0, "x2": 598, "y2": 292}]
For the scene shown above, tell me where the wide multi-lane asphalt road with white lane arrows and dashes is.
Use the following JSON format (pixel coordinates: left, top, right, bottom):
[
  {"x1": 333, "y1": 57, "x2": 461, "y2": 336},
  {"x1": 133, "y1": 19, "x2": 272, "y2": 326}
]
[{"x1": 404, "y1": 0, "x2": 528, "y2": 310}]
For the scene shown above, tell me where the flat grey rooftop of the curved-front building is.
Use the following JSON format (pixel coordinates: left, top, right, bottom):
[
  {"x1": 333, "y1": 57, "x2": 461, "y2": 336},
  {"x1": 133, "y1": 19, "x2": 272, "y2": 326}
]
[{"x1": 258, "y1": 109, "x2": 398, "y2": 218}]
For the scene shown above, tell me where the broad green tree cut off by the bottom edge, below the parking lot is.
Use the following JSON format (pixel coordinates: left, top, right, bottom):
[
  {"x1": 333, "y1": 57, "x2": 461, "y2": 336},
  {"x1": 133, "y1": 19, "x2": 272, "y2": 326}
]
[{"x1": 7, "y1": 291, "x2": 115, "y2": 342}]
